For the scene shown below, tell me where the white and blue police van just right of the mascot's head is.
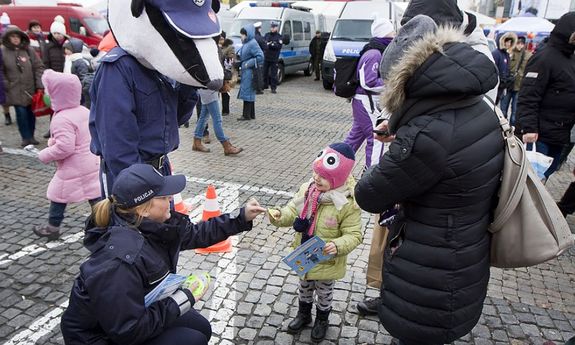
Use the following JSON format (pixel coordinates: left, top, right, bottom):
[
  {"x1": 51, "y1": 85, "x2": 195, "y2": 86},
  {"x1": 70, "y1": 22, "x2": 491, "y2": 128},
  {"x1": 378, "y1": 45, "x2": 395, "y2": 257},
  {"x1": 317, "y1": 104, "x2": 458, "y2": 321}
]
[{"x1": 227, "y1": 2, "x2": 316, "y2": 83}]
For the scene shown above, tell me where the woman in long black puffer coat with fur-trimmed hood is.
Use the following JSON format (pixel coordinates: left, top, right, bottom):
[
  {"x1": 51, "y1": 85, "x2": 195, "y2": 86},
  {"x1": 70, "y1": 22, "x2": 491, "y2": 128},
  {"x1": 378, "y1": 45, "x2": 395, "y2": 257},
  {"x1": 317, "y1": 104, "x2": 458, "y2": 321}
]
[{"x1": 355, "y1": 16, "x2": 504, "y2": 345}]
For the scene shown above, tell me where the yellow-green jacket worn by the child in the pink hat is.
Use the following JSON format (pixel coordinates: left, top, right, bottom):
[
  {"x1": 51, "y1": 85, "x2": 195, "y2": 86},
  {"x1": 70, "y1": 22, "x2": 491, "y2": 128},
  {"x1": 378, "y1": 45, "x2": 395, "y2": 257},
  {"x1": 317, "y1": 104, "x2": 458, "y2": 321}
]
[{"x1": 269, "y1": 177, "x2": 363, "y2": 280}]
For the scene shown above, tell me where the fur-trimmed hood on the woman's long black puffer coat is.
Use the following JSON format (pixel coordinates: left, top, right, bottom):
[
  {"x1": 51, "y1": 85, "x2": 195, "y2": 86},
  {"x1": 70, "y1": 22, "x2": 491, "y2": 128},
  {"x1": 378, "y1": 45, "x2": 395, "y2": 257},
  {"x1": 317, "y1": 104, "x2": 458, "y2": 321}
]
[{"x1": 381, "y1": 27, "x2": 498, "y2": 133}]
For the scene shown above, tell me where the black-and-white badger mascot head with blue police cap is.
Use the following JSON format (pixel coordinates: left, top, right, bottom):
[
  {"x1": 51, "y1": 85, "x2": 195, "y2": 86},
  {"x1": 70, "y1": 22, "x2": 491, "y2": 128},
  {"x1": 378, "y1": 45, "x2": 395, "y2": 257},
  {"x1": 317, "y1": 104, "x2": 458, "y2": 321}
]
[{"x1": 108, "y1": 0, "x2": 224, "y2": 90}]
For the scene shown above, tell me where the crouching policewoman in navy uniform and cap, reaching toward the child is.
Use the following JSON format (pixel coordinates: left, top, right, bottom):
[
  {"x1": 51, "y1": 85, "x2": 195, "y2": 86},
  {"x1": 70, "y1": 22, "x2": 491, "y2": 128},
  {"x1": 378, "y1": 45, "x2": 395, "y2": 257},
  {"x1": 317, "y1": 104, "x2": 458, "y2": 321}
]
[{"x1": 61, "y1": 164, "x2": 265, "y2": 345}]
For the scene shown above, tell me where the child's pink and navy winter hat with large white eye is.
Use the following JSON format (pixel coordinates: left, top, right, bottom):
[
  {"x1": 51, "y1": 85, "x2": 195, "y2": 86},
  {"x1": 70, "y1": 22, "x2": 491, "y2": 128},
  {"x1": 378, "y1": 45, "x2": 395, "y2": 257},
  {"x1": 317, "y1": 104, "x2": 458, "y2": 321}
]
[{"x1": 313, "y1": 143, "x2": 355, "y2": 189}]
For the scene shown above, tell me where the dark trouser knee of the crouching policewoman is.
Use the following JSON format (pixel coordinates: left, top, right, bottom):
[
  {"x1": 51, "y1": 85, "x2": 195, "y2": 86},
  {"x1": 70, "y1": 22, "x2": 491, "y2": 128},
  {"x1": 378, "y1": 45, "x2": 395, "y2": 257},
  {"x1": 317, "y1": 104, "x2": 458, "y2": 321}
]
[{"x1": 142, "y1": 309, "x2": 212, "y2": 345}]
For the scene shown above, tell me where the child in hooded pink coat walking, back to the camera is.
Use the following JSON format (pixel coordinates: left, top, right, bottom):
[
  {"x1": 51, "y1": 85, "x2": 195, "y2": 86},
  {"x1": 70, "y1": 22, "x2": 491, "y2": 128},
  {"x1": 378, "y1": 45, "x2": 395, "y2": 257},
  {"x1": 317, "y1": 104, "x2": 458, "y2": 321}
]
[{"x1": 34, "y1": 70, "x2": 101, "y2": 240}]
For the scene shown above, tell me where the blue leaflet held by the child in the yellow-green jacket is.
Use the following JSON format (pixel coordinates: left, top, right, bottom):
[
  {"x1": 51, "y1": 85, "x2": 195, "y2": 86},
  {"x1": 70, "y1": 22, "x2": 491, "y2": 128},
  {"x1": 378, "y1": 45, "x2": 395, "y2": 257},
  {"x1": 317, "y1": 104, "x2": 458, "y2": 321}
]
[{"x1": 282, "y1": 236, "x2": 333, "y2": 276}]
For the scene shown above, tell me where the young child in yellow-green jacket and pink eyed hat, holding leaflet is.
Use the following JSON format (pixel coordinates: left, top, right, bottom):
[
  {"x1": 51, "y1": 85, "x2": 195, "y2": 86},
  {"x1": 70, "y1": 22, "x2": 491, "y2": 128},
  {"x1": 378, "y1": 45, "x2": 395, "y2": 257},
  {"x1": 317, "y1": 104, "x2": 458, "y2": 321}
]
[{"x1": 269, "y1": 143, "x2": 363, "y2": 341}]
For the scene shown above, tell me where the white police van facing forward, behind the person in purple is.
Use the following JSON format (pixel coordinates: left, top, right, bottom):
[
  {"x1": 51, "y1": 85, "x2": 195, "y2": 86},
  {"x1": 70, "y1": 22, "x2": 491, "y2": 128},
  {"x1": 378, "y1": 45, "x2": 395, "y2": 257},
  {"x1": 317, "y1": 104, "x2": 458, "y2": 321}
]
[{"x1": 321, "y1": 1, "x2": 393, "y2": 90}]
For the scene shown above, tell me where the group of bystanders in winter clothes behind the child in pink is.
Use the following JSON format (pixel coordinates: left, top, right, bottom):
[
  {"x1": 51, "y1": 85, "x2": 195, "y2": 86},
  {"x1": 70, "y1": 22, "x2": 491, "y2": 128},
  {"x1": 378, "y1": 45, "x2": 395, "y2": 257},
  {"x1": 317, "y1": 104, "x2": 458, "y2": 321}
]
[{"x1": 0, "y1": 13, "x2": 100, "y2": 147}]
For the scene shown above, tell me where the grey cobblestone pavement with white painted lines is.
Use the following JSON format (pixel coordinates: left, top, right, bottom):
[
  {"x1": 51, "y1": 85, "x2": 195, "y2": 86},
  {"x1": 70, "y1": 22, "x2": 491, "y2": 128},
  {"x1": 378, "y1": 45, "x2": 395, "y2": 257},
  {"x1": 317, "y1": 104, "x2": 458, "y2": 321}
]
[{"x1": 0, "y1": 76, "x2": 575, "y2": 345}]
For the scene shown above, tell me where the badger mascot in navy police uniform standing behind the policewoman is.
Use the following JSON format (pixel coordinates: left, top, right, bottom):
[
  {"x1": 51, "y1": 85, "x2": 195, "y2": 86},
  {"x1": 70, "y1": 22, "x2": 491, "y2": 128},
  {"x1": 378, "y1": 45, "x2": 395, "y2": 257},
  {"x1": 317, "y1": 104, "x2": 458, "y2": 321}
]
[{"x1": 90, "y1": 0, "x2": 224, "y2": 196}]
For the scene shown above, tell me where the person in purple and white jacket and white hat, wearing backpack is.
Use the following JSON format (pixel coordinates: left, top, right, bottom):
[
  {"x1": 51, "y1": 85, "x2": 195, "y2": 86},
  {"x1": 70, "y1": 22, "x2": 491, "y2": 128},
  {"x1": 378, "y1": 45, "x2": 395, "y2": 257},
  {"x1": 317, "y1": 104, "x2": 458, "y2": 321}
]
[{"x1": 345, "y1": 18, "x2": 394, "y2": 167}]
